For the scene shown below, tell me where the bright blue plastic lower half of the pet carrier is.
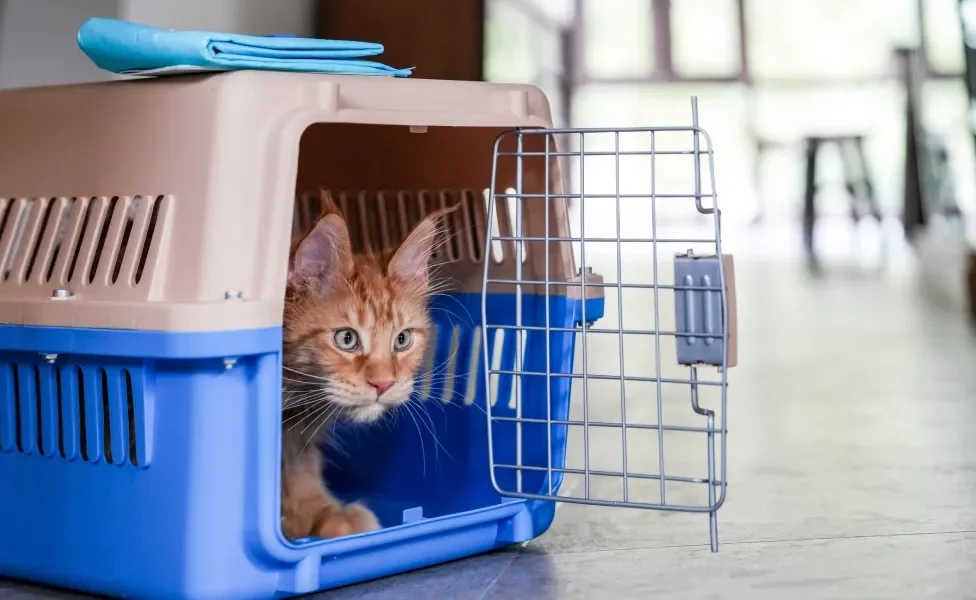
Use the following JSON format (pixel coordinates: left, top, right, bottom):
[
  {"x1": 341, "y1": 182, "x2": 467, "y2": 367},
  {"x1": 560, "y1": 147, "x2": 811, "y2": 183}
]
[{"x1": 0, "y1": 294, "x2": 595, "y2": 599}]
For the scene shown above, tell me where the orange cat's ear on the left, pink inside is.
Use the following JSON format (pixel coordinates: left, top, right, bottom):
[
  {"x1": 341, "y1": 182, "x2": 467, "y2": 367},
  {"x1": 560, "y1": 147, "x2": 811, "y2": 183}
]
[{"x1": 288, "y1": 213, "x2": 353, "y2": 287}]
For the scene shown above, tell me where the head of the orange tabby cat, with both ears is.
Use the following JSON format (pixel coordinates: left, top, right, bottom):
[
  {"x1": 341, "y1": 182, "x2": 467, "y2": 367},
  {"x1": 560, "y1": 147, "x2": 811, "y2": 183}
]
[{"x1": 284, "y1": 196, "x2": 450, "y2": 422}]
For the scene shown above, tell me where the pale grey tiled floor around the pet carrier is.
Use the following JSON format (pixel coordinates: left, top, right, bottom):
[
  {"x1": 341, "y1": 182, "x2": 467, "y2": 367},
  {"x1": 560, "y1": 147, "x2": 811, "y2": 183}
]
[{"x1": 0, "y1": 237, "x2": 976, "y2": 600}]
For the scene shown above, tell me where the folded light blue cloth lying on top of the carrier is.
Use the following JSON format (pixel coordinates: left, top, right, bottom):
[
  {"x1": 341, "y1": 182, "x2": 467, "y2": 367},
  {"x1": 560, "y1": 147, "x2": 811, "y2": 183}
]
[{"x1": 78, "y1": 18, "x2": 412, "y2": 77}]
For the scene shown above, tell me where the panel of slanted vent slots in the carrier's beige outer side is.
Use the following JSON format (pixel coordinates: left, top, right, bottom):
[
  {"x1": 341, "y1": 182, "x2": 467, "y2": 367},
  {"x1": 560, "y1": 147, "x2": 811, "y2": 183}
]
[{"x1": 0, "y1": 195, "x2": 170, "y2": 287}]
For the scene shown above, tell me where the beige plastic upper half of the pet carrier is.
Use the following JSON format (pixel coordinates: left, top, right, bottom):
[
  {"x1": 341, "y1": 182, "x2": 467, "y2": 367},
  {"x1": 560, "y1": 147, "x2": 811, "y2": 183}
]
[{"x1": 0, "y1": 71, "x2": 574, "y2": 331}]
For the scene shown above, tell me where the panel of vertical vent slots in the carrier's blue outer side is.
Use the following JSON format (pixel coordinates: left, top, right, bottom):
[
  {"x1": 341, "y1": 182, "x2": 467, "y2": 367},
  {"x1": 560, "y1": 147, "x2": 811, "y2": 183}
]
[{"x1": 0, "y1": 363, "x2": 151, "y2": 467}]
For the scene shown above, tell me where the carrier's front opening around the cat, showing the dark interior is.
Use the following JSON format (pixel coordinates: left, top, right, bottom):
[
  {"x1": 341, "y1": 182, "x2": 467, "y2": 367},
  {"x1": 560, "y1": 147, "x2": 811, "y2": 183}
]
[{"x1": 286, "y1": 124, "x2": 541, "y2": 540}]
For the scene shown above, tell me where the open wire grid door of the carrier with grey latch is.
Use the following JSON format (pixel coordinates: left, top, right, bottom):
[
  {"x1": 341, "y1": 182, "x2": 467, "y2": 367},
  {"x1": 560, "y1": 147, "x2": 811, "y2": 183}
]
[{"x1": 482, "y1": 99, "x2": 735, "y2": 551}]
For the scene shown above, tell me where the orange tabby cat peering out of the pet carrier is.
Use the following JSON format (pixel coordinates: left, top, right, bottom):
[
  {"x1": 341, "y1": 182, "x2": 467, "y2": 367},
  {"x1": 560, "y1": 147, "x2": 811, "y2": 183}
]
[{"x1": 281, "y1": 194, "x2": 453, "y2": 539}]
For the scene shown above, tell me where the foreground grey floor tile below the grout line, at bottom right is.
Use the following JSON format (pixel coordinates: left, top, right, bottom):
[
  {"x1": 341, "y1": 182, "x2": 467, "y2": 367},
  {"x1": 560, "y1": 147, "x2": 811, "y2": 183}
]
[{"x1": 484, "y1": 533, "x2": 976, "y2": 600}]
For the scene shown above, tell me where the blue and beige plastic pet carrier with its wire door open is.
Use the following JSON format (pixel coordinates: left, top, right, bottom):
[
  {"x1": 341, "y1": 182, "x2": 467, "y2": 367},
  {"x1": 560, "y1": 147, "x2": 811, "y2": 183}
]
[{"x1": 0, "y1": 71, "x2": 735, "y2": 598}]
